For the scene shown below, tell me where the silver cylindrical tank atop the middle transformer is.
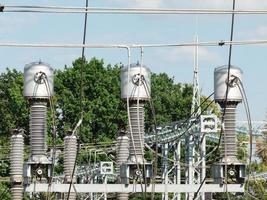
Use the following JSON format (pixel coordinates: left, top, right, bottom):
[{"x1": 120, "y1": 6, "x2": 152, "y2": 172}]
[{"x1": 120, "y1": 64, "x2": 151, "y2": 100}]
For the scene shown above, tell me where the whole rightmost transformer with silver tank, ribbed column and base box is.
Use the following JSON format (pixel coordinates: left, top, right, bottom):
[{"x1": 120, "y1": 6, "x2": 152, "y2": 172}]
[{"x1": 213, "y1": 66, "x2": 246, "y2": 184}]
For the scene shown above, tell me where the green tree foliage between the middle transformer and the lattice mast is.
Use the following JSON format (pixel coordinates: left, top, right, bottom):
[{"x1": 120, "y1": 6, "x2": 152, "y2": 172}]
[{"x1": 146, "y1": 73, "x2": 192, "y2": 128}]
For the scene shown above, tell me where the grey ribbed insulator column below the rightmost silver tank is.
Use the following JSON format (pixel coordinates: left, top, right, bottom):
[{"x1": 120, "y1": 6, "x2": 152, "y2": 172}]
[{"x1": 222, "y1": 102, "x2": 237, "y2": 160}]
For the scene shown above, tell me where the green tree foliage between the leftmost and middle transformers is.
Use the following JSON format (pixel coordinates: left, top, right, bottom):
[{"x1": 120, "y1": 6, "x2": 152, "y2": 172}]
[{"x1": 55, "y1": 58, "x2": 126, "y2": 142}]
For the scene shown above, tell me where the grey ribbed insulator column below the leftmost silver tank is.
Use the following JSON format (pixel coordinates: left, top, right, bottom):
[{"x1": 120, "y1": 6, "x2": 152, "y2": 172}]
[{"x1": 30, "y1": 102, "x2": 47, "y2": 156}]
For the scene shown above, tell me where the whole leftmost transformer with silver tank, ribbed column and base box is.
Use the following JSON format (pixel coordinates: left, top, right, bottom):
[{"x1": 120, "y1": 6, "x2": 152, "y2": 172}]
[{"x1": 23, "y1": 62, "x2": 54, "y2": 184}]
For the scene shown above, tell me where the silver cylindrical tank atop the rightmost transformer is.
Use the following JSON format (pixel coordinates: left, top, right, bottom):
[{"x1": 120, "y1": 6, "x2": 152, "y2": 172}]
[{"x1": 214, "y1": 65, "x2": 243, "y2": 102}]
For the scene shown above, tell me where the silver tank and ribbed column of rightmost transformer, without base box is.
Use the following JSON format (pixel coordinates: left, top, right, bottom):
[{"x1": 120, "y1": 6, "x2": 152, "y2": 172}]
[{"x1": 214, "y1": 66, "x2": 243, "y2": 163}]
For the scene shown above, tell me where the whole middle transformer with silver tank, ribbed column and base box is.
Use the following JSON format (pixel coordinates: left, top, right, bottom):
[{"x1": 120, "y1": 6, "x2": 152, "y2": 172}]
[{"x1": 119, "y1": 64, "x2": 152, "y2": 196}]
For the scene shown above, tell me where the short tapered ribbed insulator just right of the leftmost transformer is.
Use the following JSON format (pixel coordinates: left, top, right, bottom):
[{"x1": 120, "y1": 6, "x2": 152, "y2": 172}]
[{"x1": 64, "y1": 135, "x2": 77, "y2": 200}]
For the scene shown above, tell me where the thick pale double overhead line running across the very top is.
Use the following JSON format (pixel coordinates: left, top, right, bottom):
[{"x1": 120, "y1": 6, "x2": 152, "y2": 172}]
[{"x1": 1, "y1": 5, "x2": 267, "y2": 15}]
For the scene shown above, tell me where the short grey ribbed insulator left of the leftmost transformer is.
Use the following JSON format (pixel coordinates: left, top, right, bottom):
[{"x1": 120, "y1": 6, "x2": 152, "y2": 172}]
[{"x1": 10, "y1": 133, "x2": 24, "y2": 179}]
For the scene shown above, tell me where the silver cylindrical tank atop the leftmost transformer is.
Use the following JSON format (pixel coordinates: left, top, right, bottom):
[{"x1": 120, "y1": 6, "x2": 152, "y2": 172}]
[{"x1": 23, "y1": 62, "x2": 54, "y2": 99}]
